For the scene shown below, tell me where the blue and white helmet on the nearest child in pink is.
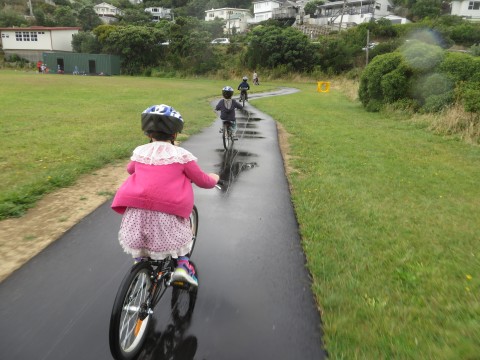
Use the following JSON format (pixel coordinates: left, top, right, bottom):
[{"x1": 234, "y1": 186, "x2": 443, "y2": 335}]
[{"x1": 142, "y1": 104, "x2": 184, "y2": 135}]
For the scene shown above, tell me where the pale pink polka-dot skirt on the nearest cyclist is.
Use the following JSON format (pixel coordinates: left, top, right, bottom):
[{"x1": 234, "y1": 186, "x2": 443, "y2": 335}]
[{"x1": 118, "y1": 208, "x2": 193, "y2": 260}]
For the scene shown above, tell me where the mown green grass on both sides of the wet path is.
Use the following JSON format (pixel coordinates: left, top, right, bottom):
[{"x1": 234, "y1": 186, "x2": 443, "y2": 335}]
[{"x1": 0, "y1": 72, "x2": 480, "y2": 360}]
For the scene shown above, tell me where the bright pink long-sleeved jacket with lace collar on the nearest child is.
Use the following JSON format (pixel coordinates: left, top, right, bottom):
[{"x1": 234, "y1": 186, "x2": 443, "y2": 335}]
[{"x1": 112, "y1": 142, "x2": 216, "y2": 218}]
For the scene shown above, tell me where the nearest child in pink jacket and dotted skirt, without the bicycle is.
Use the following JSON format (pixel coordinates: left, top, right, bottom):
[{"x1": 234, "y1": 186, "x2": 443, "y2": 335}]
[{"x1": 112, "y1": 104, "x2": 219, "y2": 286}]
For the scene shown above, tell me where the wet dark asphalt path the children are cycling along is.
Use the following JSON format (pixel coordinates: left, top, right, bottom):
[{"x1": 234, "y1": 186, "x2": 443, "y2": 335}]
[{"x1": 0, "y1": 89, "x2": 326, "y2": 360}]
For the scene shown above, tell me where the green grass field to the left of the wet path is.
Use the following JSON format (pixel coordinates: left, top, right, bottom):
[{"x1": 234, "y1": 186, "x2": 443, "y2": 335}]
[{"x1": 0, "y1": 71, "x2": 274, "y2": 219}]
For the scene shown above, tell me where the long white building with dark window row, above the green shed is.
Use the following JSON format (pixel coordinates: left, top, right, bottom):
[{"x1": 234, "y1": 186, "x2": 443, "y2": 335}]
[{"x1": 0, "y1": 26, "x2": 80, "y2": 61}]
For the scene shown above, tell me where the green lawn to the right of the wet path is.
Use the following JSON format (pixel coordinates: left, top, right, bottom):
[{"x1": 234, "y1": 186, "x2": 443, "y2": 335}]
[{"x1": 252, "y1": 83, "x2": 480, "y2": 359}]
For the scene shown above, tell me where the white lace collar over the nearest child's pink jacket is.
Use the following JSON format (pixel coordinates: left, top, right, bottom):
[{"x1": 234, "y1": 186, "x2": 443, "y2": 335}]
[{"x1": 130, "y1": 141, "x2": 197, "y2": 165}]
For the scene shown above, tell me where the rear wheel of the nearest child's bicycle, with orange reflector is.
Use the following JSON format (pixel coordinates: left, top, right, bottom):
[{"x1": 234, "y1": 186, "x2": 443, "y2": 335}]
[{"x1": 109, "y1": 262, "x2": 153, "y2": 360}]
